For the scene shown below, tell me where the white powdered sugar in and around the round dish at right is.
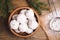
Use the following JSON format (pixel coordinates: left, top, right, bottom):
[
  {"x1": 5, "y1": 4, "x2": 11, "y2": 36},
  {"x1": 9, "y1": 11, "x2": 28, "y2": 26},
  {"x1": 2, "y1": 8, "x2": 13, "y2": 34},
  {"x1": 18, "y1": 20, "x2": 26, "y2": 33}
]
[{"x1": 48, "y1": 9, "x2": 60, "y2": 32}]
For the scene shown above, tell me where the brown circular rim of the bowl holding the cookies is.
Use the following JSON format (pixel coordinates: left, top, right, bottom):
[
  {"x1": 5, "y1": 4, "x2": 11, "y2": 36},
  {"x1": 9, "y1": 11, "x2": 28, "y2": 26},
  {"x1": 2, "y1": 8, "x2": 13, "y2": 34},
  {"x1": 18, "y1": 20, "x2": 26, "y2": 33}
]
[{"x1": 8, "y1": 7, "x2": 40, "y2": 38}]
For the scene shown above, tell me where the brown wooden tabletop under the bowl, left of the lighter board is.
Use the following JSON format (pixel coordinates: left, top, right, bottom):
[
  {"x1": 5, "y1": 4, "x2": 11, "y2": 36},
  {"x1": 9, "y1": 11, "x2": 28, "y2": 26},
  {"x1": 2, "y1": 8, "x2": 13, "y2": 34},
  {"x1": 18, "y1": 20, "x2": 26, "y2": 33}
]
[{"x1": 0, "y1": 0, "x2": 47, "y2": 40}]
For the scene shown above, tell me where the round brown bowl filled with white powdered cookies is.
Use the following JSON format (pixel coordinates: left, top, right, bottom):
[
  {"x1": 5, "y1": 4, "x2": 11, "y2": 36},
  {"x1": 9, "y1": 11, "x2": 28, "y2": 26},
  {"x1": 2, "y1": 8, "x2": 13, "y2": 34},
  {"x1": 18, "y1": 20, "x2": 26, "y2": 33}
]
[{"x1": 8, "y1": 7, "x2": 40, "y2": 38}]
